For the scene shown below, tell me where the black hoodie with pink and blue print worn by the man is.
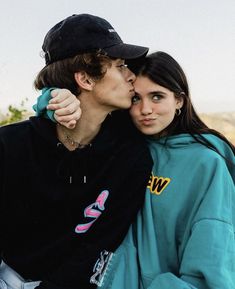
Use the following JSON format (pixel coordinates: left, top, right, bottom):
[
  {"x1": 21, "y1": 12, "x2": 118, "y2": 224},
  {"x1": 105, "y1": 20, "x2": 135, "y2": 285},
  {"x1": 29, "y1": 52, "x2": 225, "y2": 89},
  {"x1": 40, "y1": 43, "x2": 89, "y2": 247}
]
[{"x1": 0, "y1": 111, "x2": 152, "y2": 289}]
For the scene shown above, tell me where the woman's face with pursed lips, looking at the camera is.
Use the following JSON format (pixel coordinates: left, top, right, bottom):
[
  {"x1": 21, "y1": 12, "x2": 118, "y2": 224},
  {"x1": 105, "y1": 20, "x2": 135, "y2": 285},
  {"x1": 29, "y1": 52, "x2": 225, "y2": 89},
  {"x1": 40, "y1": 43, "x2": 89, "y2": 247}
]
[{"x1": 130, "y1": 76, "x2": 183, "y2": 136}]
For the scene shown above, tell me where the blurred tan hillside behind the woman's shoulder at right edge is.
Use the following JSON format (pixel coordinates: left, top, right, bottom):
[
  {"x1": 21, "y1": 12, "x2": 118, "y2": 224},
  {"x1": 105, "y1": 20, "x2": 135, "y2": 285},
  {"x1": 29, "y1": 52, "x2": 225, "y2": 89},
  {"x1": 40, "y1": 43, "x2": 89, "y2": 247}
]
[{"x1": 200, "y1": 112, "x2": 235, "y2": 145}]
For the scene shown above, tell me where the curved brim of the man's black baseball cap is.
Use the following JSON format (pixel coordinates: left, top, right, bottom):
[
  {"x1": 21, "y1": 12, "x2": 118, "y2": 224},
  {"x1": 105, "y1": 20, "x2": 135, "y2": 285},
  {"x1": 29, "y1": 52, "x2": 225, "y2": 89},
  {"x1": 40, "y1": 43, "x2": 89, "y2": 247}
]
[{"x1": 103, "y1": 43, "x2": 149, "y2": 59}]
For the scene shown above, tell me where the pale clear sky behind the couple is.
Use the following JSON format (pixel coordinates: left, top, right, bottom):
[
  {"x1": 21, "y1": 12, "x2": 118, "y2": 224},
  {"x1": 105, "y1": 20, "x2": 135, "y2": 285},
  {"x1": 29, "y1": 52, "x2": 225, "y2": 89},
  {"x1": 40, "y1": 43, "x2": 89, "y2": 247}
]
[{"x1": 0, "y1": 0, "x2": 235, "y2": 113}]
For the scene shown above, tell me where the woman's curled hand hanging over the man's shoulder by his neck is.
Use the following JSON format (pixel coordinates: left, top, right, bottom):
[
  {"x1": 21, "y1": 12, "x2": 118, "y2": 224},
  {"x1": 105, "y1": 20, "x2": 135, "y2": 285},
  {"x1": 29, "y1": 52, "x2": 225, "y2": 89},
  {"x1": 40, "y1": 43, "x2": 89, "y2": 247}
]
[{"x1": 47, "y1": 89, "x2": 82, "y2": 129}]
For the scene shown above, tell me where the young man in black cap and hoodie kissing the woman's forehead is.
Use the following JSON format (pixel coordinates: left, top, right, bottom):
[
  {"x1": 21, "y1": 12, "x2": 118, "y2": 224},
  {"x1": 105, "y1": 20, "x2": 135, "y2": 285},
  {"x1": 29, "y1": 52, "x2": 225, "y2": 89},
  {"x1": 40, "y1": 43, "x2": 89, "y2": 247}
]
[{"x1": 0, "y1": 14, "x2": 152, "y2": 289}]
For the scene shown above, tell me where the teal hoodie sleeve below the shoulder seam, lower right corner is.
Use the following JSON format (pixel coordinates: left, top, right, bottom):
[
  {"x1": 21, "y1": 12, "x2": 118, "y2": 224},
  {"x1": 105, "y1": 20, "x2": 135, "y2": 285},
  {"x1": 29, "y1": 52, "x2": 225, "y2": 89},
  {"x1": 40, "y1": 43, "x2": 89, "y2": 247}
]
[{"x1": 147, "y1": 219, "x2": 235, "y2": 289}]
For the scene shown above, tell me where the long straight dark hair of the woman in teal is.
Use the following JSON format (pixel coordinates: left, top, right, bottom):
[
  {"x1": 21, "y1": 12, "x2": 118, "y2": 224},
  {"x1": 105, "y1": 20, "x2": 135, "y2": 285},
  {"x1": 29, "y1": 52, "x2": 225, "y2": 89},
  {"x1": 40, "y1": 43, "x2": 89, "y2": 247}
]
[{"x1": 136, "y1": 51, "x2": 235, "y2": 154}]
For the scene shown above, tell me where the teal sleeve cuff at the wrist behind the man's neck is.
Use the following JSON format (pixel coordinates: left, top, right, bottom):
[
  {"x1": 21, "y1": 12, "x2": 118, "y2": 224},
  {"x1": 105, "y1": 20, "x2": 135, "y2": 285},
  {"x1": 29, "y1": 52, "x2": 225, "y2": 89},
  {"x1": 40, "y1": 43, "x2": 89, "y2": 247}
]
[{"x1": 33, "y1": 87, "x2": 56, "y2": 122}]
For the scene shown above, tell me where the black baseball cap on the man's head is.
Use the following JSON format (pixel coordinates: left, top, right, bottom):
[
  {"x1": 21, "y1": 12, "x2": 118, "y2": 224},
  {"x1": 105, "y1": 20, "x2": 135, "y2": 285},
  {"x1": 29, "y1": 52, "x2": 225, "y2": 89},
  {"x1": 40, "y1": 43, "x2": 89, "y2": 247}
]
[{"x1": 42, "y1": 14, "x2": 149, "y2": 65}]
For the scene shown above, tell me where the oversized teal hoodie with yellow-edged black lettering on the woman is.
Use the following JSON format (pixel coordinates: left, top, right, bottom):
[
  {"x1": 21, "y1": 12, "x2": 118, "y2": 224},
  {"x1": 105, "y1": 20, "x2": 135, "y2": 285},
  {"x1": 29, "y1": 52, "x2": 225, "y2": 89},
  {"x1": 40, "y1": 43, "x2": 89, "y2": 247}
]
[{"x1": 97, "y1": 134, "x2": 235, "y2": 289}]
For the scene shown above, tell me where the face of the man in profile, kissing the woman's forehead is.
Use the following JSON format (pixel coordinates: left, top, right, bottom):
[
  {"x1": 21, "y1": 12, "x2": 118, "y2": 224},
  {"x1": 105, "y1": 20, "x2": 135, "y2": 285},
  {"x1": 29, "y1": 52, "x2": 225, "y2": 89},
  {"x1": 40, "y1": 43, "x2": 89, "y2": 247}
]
[{"x1": 93, "y1": 59, "x2": 136, "y2": 110}]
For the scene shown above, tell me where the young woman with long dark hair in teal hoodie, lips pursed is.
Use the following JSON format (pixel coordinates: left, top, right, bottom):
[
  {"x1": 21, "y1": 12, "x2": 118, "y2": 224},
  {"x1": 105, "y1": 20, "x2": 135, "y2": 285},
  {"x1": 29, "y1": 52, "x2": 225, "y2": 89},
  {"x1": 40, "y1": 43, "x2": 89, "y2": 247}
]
[{"x1": 97, "y1": 52, "x2": 235, "y2": 289}]
